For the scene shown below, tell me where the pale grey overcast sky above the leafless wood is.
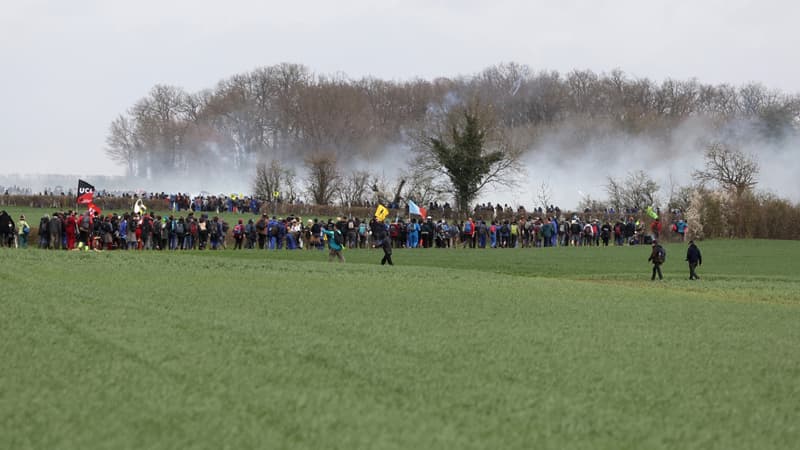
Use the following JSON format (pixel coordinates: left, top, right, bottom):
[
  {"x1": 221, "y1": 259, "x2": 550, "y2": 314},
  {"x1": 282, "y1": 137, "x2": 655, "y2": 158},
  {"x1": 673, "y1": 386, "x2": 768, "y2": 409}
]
[{"x1": 0, "y1": 0, "x2": 800, "y2": 205}]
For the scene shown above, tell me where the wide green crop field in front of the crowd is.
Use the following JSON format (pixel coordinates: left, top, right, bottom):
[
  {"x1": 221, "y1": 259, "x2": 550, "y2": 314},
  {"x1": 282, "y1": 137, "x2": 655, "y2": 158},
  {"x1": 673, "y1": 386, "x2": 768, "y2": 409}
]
[{"x1": 0, "y1": 207, "x2": 800, "y2": 449}]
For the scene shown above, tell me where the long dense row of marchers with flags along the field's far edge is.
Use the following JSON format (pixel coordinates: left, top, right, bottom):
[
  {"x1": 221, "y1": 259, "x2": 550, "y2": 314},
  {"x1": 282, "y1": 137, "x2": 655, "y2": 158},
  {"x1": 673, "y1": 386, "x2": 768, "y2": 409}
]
[{"x1": 0, "y1": 205, "x2": 687, "y2": 250}]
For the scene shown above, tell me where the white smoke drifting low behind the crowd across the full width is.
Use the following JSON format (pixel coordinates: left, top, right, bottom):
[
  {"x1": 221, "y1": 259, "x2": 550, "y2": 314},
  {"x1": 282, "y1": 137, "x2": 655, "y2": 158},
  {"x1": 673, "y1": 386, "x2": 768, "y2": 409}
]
[{"x1": 0, "y1": 118, "x2": 800, "y2": 210}]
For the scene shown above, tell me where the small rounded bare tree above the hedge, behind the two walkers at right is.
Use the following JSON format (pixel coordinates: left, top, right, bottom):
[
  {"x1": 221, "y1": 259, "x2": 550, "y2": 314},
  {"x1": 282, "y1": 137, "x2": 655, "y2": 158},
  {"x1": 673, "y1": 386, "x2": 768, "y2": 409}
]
[{"x1": 692, "y1": 142, "x2": 759, "y2": 198}]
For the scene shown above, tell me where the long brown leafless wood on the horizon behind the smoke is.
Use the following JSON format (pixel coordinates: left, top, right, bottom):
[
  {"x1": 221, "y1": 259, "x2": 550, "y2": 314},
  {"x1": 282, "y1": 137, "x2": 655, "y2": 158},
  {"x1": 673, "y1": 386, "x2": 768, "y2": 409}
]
[{"x1": 107, "y1": 63, "x2": 800, "y2": 176}]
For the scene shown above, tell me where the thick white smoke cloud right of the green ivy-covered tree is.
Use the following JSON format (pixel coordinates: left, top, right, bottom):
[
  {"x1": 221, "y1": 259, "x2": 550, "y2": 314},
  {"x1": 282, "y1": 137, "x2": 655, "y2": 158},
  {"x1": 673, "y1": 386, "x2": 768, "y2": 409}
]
[{"x1": 478, "y1": 118, "x2": 800, "y2": 210}]
